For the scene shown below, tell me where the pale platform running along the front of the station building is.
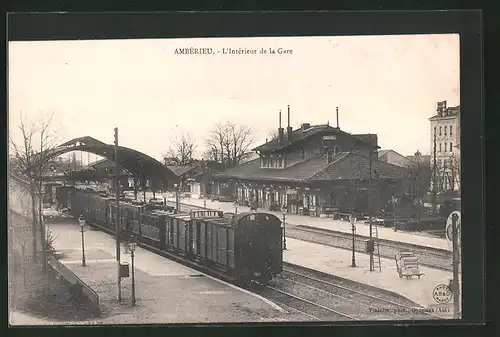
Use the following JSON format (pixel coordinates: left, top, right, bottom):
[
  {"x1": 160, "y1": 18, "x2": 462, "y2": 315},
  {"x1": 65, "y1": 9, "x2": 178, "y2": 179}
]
[{"x1": 155, "y1": 193, "x2": 450, "y2": 250}]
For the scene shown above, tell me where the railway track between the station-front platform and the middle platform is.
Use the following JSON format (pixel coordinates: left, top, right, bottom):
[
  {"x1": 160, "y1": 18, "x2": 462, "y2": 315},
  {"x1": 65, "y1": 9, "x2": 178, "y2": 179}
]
[{"x1": 286, "y1": 225, "x2": 452, "y2": 271}]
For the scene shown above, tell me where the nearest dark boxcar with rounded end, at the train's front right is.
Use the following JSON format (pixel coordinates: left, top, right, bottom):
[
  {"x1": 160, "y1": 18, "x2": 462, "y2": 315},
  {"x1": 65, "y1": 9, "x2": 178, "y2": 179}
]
[{"x1": 165, "y1": 211, "x2": 283, "y2": 283}]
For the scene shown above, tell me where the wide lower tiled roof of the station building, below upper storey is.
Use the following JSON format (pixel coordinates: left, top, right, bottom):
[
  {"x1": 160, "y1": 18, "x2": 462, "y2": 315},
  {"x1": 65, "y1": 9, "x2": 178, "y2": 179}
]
[{"x1": 214, "y1": 152, "x2": 406, "y2": 182}]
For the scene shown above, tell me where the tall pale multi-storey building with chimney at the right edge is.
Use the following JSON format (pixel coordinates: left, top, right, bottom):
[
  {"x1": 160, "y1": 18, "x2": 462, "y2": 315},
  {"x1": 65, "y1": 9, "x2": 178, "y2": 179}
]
[{"x1": 429, "y1": 101, "x2": 460, "y2": 192}]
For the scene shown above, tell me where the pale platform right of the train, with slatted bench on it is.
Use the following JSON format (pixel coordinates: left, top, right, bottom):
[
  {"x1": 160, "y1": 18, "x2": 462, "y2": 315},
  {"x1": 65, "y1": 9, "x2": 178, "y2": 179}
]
[{"x1": 283, "y1": 238, "x2": 460, "y2": 318}]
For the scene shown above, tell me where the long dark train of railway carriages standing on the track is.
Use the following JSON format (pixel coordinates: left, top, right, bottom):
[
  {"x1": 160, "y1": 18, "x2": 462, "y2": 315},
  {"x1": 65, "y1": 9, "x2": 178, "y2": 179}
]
[{"x1": 54, "y1": 186, "x2": 283, "y2": 286}]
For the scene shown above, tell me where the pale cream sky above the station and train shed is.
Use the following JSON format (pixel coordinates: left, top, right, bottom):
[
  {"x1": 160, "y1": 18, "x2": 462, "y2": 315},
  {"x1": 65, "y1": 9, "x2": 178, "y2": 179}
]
[{"x1": 8, "y1": 34, "x2": 460, "y2": 163}]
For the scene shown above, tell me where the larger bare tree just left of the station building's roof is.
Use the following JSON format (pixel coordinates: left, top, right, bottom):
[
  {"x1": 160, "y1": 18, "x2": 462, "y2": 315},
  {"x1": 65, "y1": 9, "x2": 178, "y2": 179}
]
[{"x1": 203, "y1": 122, "x2": 255, "y2": 168}]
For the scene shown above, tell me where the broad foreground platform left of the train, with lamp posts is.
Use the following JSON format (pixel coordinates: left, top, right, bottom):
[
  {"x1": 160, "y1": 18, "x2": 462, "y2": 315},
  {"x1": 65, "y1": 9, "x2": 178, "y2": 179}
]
[{"x1": 50, "y1": 223, "x2": 304, "y2": 324}]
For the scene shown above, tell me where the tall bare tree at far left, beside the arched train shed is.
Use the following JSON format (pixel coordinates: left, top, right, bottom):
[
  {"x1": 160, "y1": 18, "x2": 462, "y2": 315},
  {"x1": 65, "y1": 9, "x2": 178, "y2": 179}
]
[{"x1": 9, "y1": 114, "x2": 58, "y2": 268}]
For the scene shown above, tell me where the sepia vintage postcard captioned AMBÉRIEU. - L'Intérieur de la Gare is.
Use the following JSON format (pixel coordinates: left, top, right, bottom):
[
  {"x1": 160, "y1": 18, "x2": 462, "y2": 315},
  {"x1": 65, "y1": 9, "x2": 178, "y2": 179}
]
[{"x1": 8, "y1": 34, "x2": 462, "y2": 325}]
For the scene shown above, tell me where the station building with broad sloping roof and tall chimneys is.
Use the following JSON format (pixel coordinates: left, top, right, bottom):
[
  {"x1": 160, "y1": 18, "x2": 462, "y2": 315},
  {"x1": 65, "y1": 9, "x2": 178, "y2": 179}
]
[{"x1": 214, "y1": 107, "x2": 408, "y2": 216}]
